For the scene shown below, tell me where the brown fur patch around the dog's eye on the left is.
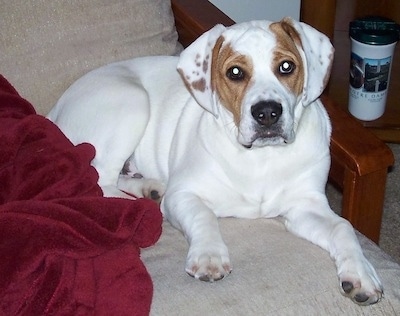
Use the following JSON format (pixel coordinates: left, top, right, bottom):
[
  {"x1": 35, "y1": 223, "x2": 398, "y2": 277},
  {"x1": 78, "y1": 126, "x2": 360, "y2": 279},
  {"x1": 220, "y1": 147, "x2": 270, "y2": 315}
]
[{"x1": 211, "y1": 36, "x2": 253, "y2": 125}]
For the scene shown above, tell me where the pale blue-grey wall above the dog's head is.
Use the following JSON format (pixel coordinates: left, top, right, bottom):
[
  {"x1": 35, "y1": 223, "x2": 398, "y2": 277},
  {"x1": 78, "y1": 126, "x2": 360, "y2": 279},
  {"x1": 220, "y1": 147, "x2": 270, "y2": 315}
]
[{"x1": 209, "y1": 0, "x2": 300, "y2": 23}]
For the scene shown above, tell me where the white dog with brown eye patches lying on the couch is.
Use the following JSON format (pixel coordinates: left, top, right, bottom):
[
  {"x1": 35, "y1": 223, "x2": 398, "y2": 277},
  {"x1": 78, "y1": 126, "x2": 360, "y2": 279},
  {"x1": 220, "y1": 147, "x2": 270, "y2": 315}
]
[{"x1": 49, "y1": 18, "x2": 383, "y2": 305}]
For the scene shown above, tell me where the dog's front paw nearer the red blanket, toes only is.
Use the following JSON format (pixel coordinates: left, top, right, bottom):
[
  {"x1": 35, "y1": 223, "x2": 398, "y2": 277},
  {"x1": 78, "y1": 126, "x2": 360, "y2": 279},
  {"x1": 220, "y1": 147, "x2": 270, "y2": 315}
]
[{"x1": 186, "y1": 245, "x2": 232, "y2": 282}]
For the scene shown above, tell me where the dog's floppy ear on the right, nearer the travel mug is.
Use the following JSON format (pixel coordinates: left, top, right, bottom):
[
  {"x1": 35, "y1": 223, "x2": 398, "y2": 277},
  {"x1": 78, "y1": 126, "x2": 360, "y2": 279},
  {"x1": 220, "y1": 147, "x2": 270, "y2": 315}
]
[{"x1": 280, "y1": 18, "x2": 334, "y2": 106}]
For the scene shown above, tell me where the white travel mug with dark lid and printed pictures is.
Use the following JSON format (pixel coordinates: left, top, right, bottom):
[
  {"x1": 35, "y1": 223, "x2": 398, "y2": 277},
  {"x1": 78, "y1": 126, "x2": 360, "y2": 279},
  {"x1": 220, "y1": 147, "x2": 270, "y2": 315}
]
[{"x1": 349, "y1": 17, "x2": 400, "y2": 121}]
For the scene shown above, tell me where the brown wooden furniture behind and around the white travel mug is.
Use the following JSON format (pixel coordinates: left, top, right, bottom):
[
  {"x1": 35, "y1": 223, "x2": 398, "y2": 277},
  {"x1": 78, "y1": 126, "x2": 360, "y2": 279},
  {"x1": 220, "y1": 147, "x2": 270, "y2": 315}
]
[{"x1": 301, "y1": 0, "x2": 400, "y2": 143}]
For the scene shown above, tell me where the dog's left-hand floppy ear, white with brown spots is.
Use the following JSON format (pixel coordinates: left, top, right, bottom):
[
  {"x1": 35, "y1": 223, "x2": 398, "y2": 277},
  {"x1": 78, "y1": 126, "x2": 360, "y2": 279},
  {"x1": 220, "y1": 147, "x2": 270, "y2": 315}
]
[{"x1": 177, "y1": 24, "x2": 226, "y2": 117}]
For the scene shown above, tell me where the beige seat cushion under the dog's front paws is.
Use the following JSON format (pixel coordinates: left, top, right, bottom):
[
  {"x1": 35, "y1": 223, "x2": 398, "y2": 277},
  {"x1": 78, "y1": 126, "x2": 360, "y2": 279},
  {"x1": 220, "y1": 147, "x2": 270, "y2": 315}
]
[{"x1": 142, "y1": 218, "x2": 400, "y2": 316}]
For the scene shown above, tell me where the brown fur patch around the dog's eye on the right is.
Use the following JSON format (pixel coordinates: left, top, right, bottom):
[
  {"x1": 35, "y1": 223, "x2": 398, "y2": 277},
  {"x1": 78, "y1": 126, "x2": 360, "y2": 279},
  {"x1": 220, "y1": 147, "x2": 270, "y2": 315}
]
[{"x1": 270, "y1": 19, "x2": 304, "y2": 95}]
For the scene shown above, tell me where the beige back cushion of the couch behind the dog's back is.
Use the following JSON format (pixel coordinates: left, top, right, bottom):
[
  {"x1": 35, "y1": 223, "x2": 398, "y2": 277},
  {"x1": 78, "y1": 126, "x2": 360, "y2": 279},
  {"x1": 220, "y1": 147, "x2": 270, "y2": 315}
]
[{"x1": 0, "y1": 0, "x2": 179, "y2": 114}]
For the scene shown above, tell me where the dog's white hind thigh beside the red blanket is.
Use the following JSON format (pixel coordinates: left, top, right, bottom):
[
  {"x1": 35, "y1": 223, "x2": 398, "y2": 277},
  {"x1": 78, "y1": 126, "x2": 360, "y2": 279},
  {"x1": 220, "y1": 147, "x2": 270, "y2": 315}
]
[{"x1": 49, "y1": 70, "x2": 155, "y2": 199}]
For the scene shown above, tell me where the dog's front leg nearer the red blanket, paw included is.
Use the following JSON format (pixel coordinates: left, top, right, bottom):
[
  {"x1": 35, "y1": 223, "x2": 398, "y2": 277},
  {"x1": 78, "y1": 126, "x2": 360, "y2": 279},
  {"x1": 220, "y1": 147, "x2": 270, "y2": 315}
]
[{"x1": 163, "y1": 193, "x2": 232, "y2": 282}]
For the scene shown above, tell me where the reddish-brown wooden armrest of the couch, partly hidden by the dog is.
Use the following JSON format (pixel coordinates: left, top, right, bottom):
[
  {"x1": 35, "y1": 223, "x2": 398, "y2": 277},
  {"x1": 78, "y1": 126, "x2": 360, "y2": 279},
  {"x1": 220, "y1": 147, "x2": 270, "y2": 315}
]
[{"x1": 172, "y1": 0, "x2": 393, "y2": 243}]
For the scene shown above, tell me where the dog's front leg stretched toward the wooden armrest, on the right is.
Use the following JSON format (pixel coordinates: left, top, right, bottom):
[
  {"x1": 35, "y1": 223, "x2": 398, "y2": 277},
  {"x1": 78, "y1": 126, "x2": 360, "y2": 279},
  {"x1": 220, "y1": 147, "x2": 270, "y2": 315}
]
[{"x1": 285, "y1": 197, "x2": 383, "y2": 305}]
